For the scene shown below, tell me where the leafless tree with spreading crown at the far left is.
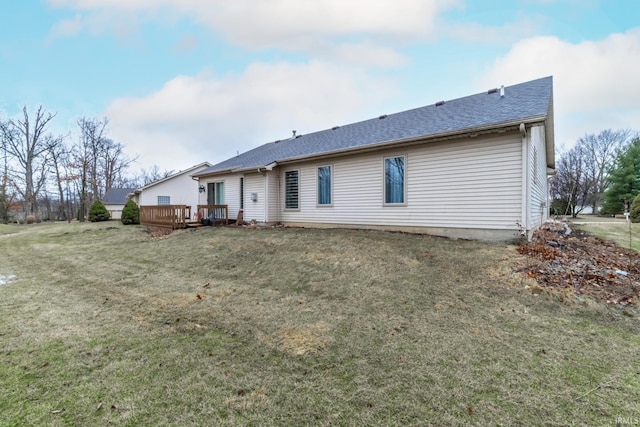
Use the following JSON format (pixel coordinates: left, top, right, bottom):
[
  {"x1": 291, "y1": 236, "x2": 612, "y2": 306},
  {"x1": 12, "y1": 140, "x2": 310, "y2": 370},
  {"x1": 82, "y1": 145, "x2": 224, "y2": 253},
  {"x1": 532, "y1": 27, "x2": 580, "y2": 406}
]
[{"x1": 0, "y1": 106, "x2": 59, "y2": 219}]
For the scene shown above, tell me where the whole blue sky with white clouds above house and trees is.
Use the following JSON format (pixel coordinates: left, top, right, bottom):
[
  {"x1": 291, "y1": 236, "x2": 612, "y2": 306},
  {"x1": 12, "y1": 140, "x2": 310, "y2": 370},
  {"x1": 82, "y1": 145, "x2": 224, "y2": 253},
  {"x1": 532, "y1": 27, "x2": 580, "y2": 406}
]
[{"x1": 0, "y1": 0, "x2": 640, "y2": 174}]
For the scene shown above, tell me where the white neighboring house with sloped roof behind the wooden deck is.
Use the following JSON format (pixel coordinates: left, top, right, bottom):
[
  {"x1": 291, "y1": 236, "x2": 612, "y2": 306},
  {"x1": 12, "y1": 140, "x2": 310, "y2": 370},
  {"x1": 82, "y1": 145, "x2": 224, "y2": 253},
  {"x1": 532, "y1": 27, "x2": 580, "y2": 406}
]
[{"x1": 129, "y1": 162, "x2": 211, "y2": 213}]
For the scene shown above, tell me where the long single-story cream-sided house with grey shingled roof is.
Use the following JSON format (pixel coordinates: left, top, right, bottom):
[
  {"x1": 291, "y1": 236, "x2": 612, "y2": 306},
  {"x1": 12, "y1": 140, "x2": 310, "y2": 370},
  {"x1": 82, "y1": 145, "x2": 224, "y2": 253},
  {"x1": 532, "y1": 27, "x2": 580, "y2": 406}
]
[{"x1": 194, "y1": 77, "x2": 555, "y2": 240}]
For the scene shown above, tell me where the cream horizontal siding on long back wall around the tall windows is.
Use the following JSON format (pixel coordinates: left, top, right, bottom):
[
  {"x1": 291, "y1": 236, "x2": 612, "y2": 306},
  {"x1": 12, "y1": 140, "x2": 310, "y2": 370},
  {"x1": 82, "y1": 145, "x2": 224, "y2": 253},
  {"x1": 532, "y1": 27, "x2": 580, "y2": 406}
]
[{"x1": 282, "y1": 132, "x2": 524, "y2": 234}]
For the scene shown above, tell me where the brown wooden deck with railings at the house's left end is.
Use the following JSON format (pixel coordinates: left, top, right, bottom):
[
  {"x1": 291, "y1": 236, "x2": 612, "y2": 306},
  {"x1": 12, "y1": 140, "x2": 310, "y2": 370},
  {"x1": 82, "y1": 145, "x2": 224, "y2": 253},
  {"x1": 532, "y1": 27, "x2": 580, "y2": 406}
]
[{"x1": 140, "y1": 205, "x2": 229, "y2": 230}]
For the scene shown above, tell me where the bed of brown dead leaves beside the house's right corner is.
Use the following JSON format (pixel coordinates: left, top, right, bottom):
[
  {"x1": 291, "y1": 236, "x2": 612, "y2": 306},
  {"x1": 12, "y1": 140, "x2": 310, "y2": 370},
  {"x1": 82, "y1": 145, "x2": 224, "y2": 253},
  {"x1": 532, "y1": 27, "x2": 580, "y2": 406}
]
[{"x1": 519, "y1": 223, "x2": 640, "y2": 306}]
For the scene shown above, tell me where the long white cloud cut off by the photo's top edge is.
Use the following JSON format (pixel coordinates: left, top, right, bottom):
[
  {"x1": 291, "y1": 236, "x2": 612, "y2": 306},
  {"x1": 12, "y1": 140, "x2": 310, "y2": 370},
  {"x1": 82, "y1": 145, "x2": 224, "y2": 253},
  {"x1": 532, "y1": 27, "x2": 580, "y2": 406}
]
[{"x1": 49, "y1": 0, "x2": 460, "y2": 50}]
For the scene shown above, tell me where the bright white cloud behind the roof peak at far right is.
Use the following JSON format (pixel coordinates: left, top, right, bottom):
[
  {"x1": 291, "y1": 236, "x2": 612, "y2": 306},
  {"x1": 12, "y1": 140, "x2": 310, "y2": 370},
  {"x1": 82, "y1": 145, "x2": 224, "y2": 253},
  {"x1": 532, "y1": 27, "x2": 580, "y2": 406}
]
[{"x1": 479, "y1": 27, "x2": 640, "y2": 145}]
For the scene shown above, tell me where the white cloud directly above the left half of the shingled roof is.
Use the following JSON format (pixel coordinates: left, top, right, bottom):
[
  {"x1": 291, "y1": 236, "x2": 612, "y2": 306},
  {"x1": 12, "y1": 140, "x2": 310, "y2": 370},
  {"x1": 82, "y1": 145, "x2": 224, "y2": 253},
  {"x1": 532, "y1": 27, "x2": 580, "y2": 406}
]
[{"x1": 104, "y1": 61, "x2": 393, "y2": 169}]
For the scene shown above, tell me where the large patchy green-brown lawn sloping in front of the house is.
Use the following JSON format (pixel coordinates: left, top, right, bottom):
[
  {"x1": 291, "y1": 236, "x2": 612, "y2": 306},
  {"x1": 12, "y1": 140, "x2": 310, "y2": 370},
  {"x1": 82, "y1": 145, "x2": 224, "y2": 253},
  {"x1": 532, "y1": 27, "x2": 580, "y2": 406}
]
[{"x1": 0, "y1": 222, "x2": 640, "y2": 426}]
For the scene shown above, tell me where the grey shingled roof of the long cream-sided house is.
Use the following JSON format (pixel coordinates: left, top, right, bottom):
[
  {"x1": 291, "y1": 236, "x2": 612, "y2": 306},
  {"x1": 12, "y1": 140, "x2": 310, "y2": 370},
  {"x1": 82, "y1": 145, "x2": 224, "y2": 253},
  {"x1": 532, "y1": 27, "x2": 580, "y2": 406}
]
[{"x1": 194, "y1": 77, "x2": 554, "y2": 176}]
